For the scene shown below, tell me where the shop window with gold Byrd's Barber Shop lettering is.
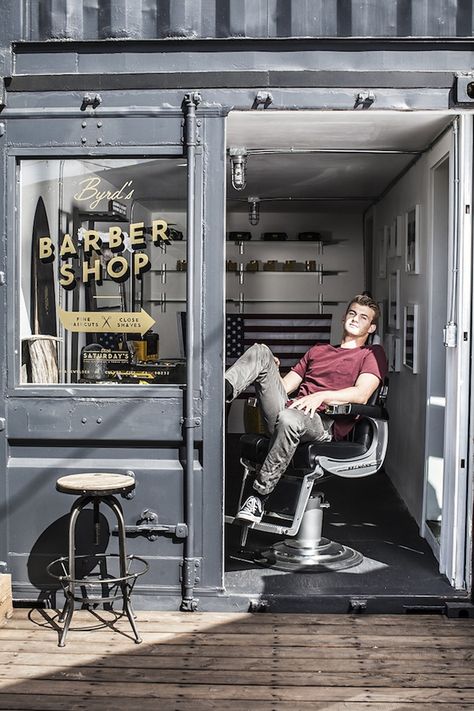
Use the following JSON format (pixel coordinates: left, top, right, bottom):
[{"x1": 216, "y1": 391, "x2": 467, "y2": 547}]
[{"x1": 17, "y1": 158, "x2": 187, "y2": 385}]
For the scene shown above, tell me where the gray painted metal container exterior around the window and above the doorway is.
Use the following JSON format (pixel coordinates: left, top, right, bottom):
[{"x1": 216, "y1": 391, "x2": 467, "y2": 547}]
[{"x1": 0, "y1": 0, "x2": 474, "y2": 608}]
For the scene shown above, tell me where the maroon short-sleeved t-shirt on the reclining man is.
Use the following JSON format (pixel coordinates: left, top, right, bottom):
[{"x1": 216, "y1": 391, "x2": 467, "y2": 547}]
[{"x1": 291, "y1": 344, "x2": 387, "y2": 440}]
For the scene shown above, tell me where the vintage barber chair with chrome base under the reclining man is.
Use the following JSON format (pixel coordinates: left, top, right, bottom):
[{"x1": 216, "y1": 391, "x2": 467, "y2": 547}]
[{"x1": 226, "y1": 381, "x2": 388, "y2": 572}]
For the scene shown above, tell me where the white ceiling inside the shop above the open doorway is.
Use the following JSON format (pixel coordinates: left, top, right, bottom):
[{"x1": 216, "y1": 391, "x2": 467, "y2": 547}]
[{"x1": 227, "y1": 111, "x2": 453, "y2": 211}]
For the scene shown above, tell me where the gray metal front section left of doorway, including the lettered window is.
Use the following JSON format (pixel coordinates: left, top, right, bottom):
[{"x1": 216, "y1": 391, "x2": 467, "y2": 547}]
[{"x1": 0, "y1": 95, "x2": 228, "y2": 606}]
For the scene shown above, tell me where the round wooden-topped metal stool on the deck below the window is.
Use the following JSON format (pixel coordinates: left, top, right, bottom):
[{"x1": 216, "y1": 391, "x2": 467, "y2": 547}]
[{"x1": 47, "y1": 472, "x2": 148, "y2": 647}]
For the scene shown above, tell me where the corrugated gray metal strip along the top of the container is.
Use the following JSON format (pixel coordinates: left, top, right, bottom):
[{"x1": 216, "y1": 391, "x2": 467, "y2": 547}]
[{"x1": 23, "y1": 0, "x2": 473, "y2": 40}]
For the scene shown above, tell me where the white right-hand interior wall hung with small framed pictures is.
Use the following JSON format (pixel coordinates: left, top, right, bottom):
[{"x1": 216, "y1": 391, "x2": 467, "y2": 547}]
[{"x1": 373, "y1": 136, "x2": 450, "y2": 524}]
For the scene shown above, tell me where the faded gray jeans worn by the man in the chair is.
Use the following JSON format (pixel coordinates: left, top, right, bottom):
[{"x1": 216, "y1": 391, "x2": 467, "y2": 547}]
[{"x1": 225, "y1": 343, "x2": 333, "y2": 495}]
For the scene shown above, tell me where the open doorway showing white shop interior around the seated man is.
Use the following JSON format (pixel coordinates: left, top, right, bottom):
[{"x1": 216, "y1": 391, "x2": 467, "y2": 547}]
[{"x1": 226, "y1": 110, "x2": 472, "y2": 609}]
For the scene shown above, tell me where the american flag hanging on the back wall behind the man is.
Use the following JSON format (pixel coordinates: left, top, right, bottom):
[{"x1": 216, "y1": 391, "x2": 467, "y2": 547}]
[{"x1": 226, "y1": 313, "x2": 332, "y2": 368}]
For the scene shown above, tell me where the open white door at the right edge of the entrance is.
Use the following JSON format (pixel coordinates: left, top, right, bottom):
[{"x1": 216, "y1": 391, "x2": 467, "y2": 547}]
[{"x1": 422, "y1": 114, "x2": 472, "y2": 589}]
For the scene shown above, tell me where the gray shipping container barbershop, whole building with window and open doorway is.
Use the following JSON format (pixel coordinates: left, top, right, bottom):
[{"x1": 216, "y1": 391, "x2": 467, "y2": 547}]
[{"x1": 0, "y1": 0, "x2": 474, "y2": 617}]
